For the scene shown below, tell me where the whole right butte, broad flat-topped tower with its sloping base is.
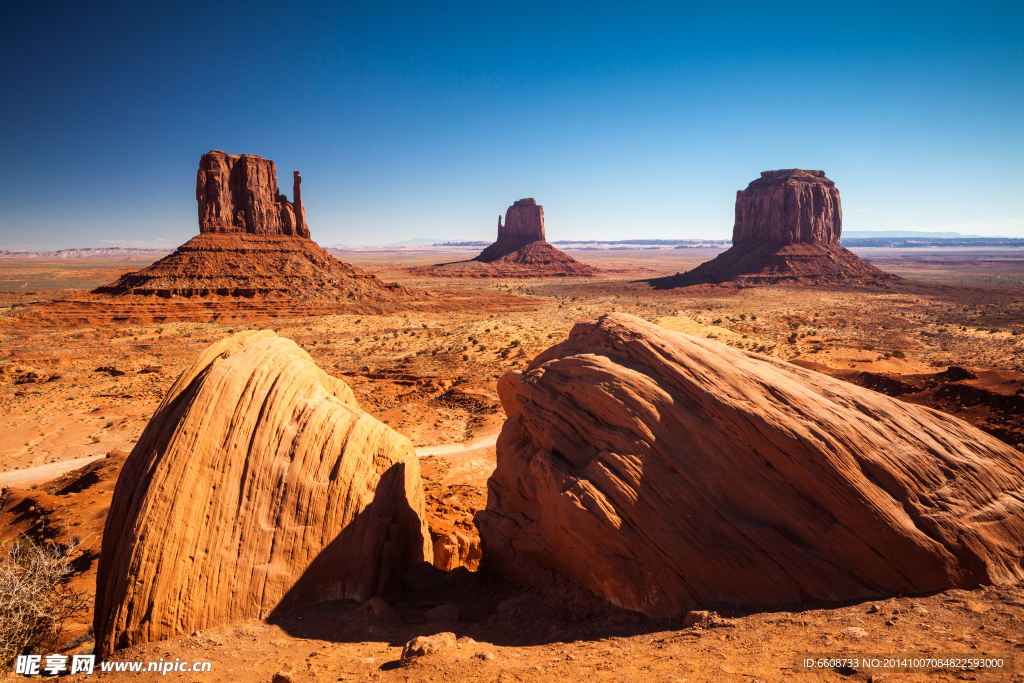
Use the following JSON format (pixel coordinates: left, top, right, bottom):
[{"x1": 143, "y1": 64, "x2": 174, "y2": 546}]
[{"x1": 652, "y1": 168, "x2": 899, "y2": 287}]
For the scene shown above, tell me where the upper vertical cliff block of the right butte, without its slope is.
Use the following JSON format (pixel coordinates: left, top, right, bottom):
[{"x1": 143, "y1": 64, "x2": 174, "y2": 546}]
[{"x1": 732, "y1": 168, "x2": 843, "y2": 245}]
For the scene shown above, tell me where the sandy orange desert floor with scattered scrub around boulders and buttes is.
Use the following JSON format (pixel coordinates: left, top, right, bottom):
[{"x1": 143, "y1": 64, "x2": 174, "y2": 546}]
[{"x1": 0, "y1": 249, "x2": 1024, "y2": 682}]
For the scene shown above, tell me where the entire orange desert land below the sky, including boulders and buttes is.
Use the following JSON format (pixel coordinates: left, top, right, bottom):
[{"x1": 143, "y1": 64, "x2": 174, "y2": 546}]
[{"x1": 0, "y1": 157, "x2": 1024, "y2": 683}]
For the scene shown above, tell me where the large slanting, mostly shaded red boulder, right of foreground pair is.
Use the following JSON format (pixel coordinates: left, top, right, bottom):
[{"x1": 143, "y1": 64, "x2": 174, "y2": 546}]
[{"x1": 476, "y1": 313, "x2": 1024, "y2": 616}]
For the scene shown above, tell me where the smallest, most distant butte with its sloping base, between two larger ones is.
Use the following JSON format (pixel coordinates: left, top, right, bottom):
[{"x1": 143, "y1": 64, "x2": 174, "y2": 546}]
[{"x1": 410, "y1": 198, "x2": 596, "y2": 278}]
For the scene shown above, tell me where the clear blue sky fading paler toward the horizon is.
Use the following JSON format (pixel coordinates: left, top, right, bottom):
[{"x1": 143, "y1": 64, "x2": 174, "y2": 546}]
[{"x1": 0, "y1": 0, "x2": 1024, "y2": 250}]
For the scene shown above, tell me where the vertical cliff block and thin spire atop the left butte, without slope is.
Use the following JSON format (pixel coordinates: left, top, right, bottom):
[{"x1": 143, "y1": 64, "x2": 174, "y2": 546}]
[{"x1": 196, "y1": 150, "x2": 309, "y2": 238}]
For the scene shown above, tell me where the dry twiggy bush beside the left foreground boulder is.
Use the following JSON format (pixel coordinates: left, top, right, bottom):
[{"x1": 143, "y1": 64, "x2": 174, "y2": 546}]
[{"x1": 0, "y1": 537, "x2": 89, "y2": 667}]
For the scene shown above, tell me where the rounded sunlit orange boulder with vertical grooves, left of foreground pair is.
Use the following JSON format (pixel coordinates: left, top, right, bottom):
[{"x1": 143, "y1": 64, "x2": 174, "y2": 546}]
[{"x1": 94, "y1": 331, "x2": 432, "y2": 656}]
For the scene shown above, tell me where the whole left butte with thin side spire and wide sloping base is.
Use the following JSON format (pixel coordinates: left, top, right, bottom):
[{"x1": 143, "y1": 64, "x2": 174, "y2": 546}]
[{"x1": 94, "y1": 151, "x2": 425, "y2": 305}]
